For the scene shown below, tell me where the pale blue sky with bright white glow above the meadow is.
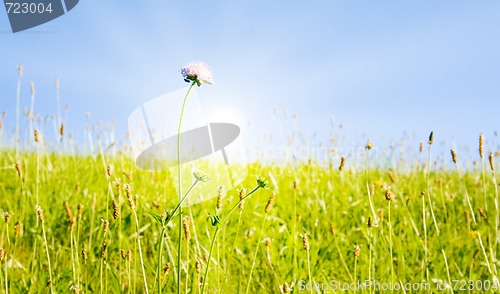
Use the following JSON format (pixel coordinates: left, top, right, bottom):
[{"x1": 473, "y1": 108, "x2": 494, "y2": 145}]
[{"x1": 0, "y1": 0, "x2": 500, "y2": 161}]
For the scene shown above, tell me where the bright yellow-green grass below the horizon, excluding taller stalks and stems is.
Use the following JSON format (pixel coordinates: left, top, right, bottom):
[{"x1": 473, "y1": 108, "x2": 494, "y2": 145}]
[{"x1": 0, "y1": 151, "x2": 498, "y2": 293}]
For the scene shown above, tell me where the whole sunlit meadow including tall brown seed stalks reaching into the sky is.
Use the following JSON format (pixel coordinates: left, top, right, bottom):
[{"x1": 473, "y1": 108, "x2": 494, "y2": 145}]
[{"x1": 0, "y1": 65, "x2": 500, "y2": 293}]
